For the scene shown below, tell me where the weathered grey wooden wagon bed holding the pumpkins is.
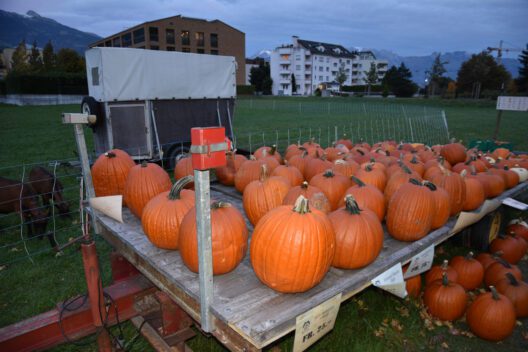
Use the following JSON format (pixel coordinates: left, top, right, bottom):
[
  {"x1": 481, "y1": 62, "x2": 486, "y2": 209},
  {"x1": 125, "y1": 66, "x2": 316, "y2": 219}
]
[{"x1": 96, "y1": 182, "x2": 528, "y2": 350}]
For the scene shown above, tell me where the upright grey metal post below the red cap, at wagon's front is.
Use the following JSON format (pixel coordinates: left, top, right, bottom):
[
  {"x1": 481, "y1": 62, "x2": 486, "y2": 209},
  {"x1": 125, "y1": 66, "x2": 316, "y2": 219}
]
[{"x1": 194, "y1": 170, "x2": 214, "y2": 332}]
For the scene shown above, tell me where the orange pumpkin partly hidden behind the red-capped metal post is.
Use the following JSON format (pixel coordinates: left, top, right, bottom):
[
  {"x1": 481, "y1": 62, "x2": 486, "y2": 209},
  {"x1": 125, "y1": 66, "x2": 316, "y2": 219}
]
[{"x1": 178, "y1": 202, "x2": 248, "y2": 275}]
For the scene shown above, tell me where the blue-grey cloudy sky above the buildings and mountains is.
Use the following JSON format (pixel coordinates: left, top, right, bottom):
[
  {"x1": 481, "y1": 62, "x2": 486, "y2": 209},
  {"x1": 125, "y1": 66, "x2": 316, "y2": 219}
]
[{"x1": 0, "y1": 0, "x2": 528, "y2": 57}]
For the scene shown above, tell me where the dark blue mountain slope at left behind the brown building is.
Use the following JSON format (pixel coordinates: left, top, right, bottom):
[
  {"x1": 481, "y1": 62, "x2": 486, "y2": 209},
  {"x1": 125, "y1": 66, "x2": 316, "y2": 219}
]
[{"x1": 0, "y1": 10, "x2": 101, "y2": 54}]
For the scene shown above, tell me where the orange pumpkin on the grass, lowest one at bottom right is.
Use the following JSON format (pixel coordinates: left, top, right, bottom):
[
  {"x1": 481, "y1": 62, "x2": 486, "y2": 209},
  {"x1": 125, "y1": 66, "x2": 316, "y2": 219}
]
[{"x1": 466, "y1": 286, "x2": 515, "y2": 341}]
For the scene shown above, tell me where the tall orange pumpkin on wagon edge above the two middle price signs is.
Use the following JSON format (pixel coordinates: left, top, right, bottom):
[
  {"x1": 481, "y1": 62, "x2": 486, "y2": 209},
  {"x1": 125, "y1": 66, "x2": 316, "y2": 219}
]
[{"x1": 386, "y1": 179, "x2": 435, "y2": 241}]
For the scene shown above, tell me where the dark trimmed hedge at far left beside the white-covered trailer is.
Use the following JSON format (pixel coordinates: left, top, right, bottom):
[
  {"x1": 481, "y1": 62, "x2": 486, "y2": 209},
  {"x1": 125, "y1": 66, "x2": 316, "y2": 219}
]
[{"x1": 5, "y1": 73, "x2": 88, "y2": 95}]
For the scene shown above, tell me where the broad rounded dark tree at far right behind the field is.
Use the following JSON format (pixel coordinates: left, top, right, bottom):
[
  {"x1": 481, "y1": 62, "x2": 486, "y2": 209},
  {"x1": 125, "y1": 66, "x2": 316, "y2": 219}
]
[{"x1": 457, "y1": 52, "x2": 511, "y2": 98}]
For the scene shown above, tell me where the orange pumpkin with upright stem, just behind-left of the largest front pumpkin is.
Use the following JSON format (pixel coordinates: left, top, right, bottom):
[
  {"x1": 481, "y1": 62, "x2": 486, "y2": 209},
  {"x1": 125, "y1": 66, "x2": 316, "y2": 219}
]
[{"x1": 242, "y1": 165, "x2": 290, "y2": 225}]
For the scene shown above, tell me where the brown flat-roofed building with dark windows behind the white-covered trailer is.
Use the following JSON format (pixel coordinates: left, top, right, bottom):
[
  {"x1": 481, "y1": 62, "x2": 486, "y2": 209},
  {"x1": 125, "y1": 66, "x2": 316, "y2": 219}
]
[{"x1": 90, "y1": 15, "x2": 246, "y2": 84}]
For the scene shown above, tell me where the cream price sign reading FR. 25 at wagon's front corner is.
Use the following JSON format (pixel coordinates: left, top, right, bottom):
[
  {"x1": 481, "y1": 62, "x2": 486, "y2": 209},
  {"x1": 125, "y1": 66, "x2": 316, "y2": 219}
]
[{"x1": 293, "y1": 293, "x2": 341, "y2": 352}]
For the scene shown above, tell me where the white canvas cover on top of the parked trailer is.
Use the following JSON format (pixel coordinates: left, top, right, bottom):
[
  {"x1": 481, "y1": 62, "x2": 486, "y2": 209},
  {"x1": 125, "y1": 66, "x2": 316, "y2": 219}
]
[{"x1": 85, "y1": 48, "x2": 236, "y2": 102}]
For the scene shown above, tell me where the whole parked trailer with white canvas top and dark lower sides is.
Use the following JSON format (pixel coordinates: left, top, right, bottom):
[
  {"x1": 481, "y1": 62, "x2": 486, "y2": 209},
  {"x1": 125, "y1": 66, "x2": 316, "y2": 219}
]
[{"x1": 81, "y1": 48, "x2": 236, "y2": 164}]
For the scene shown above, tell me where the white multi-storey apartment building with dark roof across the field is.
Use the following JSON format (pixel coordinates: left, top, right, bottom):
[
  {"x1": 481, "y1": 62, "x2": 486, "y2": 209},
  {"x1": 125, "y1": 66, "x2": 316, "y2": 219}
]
[{"x1": 270, "y1": 36, "x2": 388, "y2": 95}]
